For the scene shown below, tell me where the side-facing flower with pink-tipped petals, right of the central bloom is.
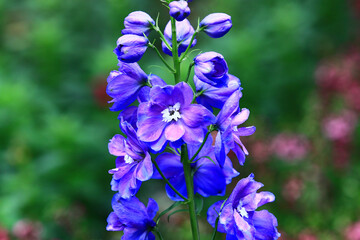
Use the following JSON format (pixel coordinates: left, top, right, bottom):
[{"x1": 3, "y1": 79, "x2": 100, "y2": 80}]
[{"x1": 215, "y1": 91, "x2": 256, "y2": 165}]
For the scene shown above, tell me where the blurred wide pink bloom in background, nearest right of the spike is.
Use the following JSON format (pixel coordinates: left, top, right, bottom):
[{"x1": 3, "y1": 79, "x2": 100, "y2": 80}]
[{"x1": 270, "y1": 133, "x2": 310, "y2": 162}]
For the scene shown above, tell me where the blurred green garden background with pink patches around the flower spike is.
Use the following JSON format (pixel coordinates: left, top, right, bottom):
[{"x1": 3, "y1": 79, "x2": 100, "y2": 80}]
[{"x1": 0, "y1": 0, "x2": 360, "y2": 240}]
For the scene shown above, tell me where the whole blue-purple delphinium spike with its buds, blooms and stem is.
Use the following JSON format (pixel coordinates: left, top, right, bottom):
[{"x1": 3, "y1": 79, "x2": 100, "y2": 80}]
[{"x1": 106, "y1": 0, "x2": 279, "y2": 240}]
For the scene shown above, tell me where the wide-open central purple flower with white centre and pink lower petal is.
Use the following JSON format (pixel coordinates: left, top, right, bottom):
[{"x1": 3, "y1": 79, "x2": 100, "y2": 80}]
[{"x1": 137, "y1": 82, "x2": 215, "y2": 151}]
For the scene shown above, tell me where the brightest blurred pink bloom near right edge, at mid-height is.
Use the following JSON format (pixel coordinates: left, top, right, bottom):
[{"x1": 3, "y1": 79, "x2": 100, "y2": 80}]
[{"x1": 323, "y1": 110, "x2": 357, "y2": 142}]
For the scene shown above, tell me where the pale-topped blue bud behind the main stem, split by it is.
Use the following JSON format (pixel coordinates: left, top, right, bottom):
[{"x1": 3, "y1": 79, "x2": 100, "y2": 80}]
[{"x1": 162, "y1": 19, "x2": 196, "y2": 56}]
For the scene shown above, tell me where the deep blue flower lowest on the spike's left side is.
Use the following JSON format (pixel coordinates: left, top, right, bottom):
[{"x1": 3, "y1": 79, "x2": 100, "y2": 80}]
[{"x1": 106, "y1": 193, "x2": 159, "y2": 240}]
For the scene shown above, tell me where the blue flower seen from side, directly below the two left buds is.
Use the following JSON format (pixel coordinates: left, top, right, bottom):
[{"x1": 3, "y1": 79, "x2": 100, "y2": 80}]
[{"x1": 106, "y1": 62, "x2": 148, "y2": 111}]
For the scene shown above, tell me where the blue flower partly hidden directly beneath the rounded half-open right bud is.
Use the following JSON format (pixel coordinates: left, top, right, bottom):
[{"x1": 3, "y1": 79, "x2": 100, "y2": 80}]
[{"x1": 194, "y1": 74, "x2": 242, "y2": 111}]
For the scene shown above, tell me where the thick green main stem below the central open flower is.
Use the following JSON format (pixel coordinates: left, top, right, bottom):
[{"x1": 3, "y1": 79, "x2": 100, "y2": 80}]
[{"x1": 181, "y1": 144, "x2": 200, "y2": 240}]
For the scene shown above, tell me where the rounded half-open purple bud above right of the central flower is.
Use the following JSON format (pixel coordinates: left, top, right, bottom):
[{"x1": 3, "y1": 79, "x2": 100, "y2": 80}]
[{"x1": 194, "y1": 52, "x2": 229, "y2": 87}]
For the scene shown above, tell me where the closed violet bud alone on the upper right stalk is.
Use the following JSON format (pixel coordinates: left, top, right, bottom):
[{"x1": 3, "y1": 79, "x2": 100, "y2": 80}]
[{"x1": 200, "y1": 13, "x2": 232, "y2": 38}]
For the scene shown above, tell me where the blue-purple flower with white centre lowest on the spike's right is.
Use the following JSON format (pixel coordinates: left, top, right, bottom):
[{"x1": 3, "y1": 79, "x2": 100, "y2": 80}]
[{"x1": 208, "y1": 174, "x2": 280, "y2": 240}]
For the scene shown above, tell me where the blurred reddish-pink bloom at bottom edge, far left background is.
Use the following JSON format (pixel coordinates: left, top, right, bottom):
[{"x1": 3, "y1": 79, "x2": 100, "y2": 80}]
[{"x1": 13, "y1": 220, "x2": 42, "y2": 240}]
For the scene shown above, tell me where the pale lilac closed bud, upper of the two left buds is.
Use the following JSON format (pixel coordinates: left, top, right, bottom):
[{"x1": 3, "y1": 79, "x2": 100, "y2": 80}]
[{"x1": 121, "y1": 11, "x2": 155, "y2": 36}]
